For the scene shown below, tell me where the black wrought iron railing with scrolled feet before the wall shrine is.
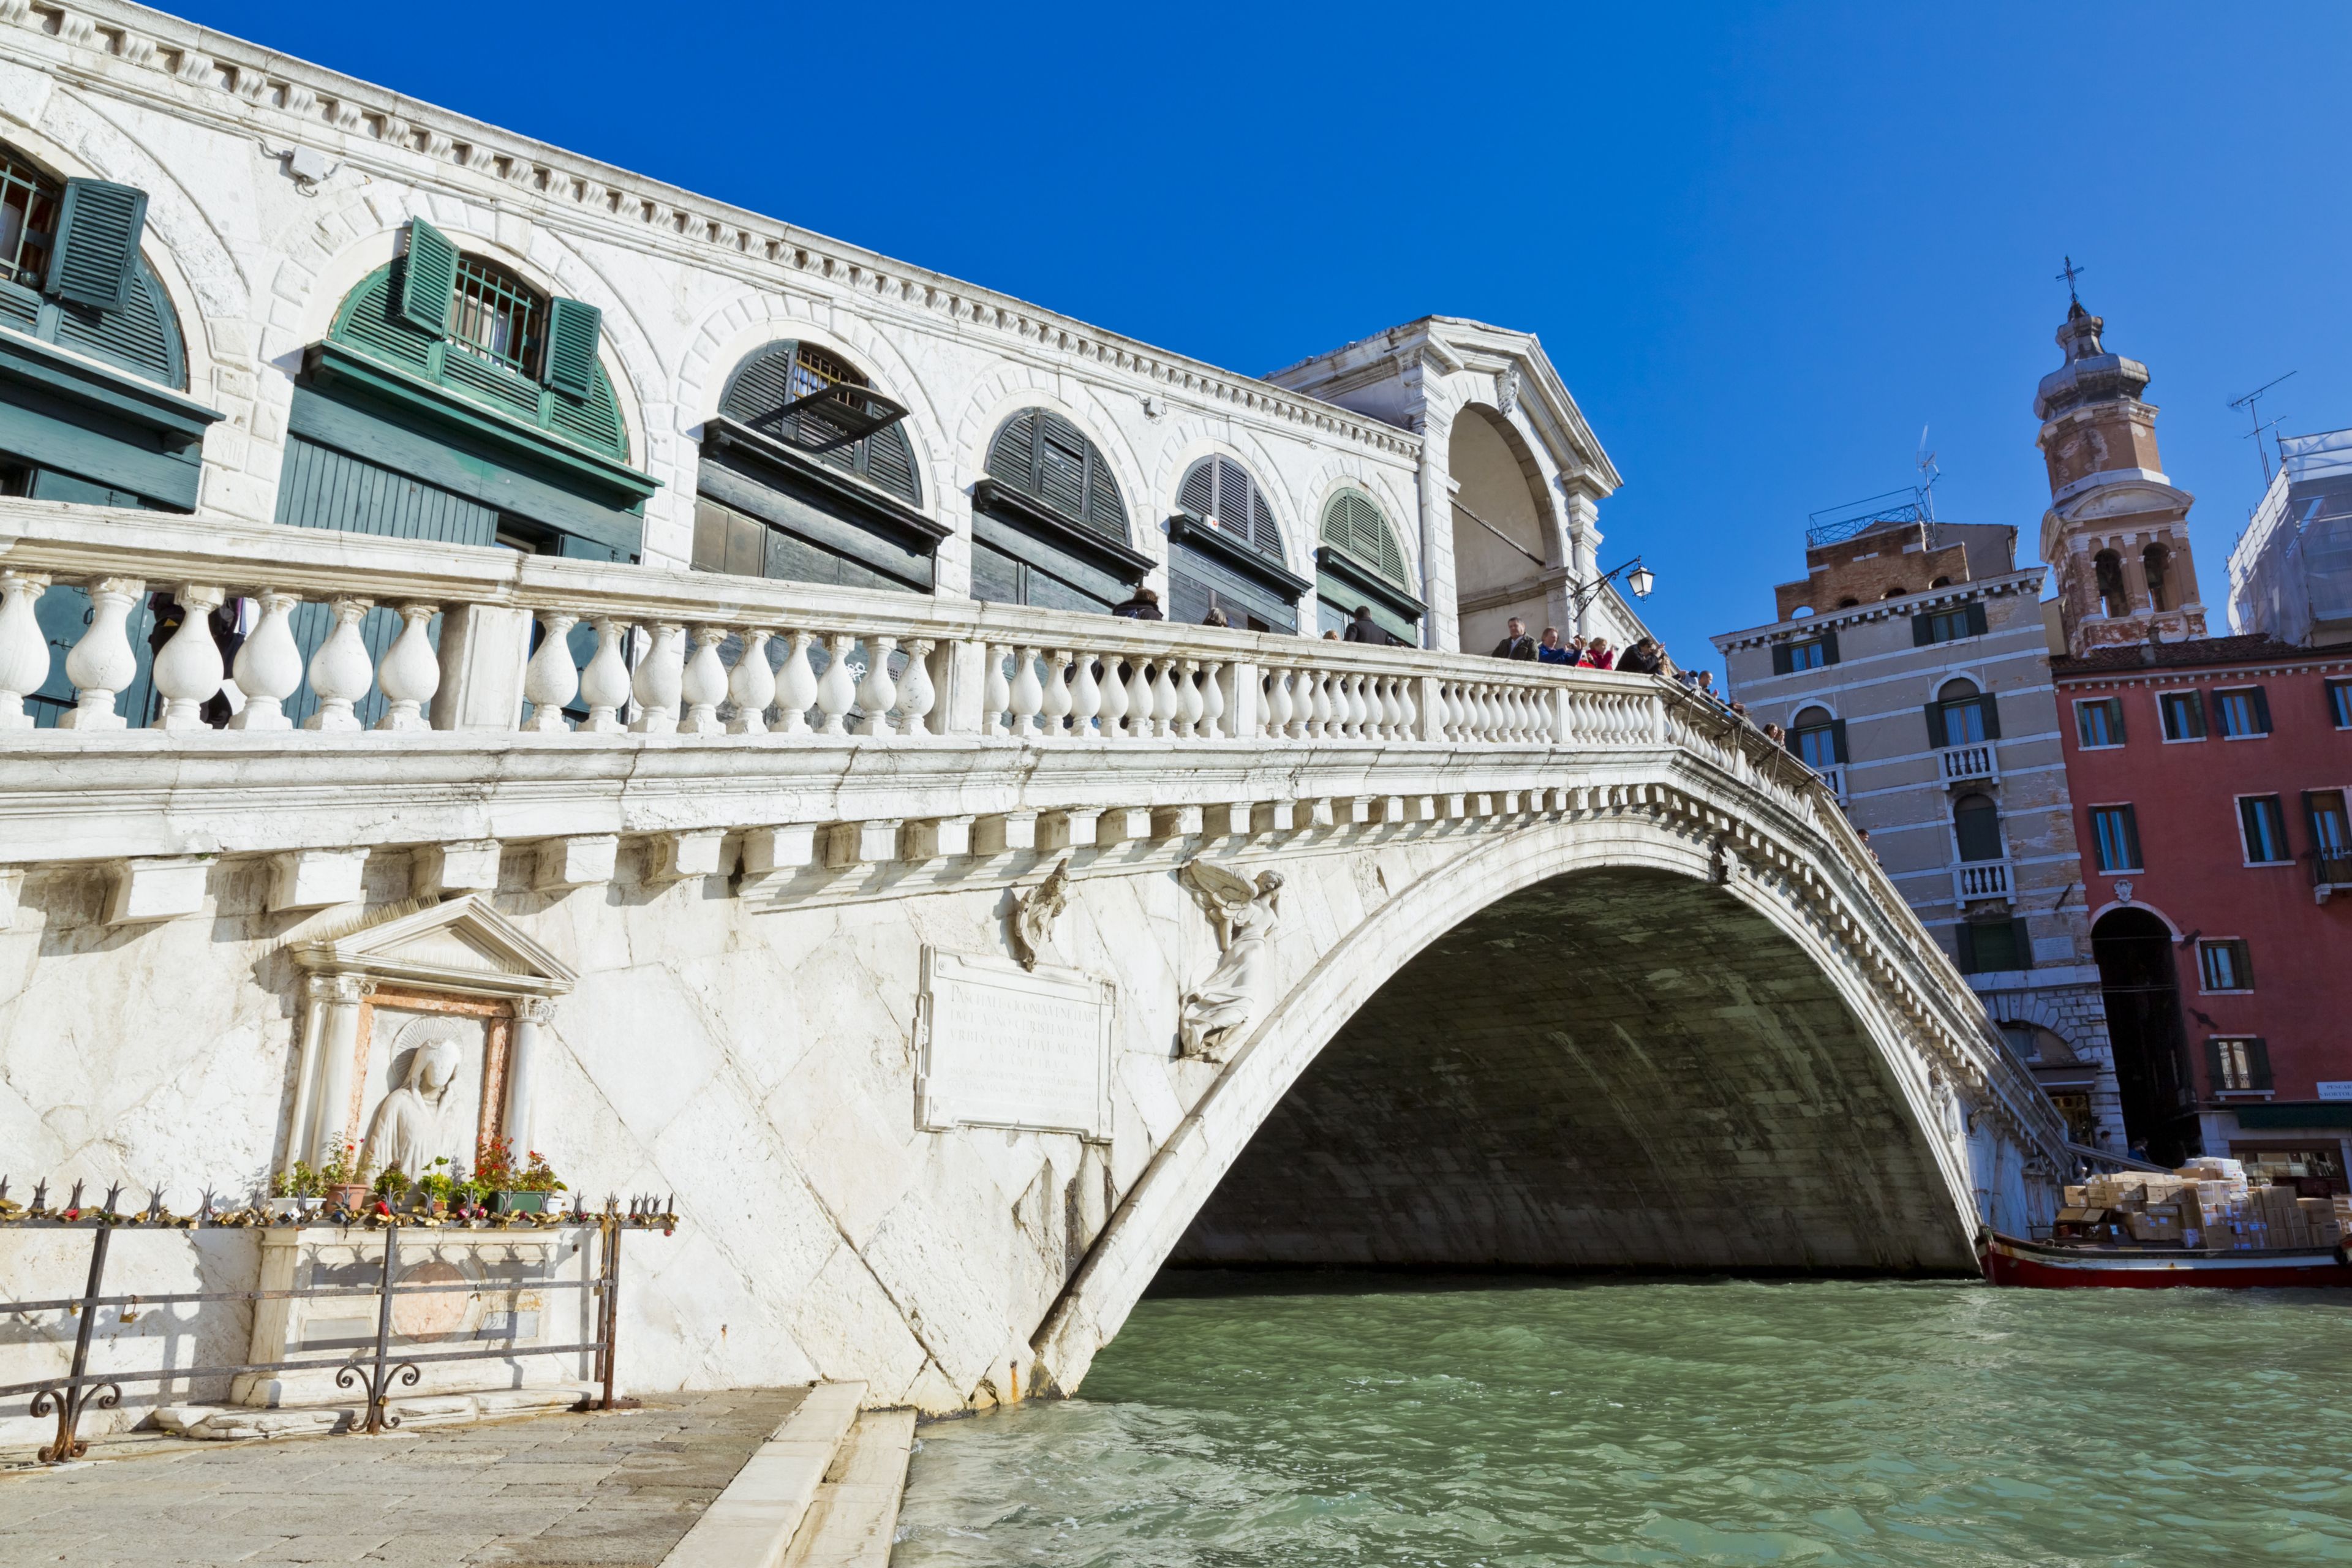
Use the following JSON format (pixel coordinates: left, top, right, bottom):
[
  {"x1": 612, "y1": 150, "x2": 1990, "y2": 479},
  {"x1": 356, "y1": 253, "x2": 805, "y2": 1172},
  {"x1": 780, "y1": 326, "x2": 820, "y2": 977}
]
[{"x1": 0, "y1": 1180, "x2": 677, "y2": 1464}]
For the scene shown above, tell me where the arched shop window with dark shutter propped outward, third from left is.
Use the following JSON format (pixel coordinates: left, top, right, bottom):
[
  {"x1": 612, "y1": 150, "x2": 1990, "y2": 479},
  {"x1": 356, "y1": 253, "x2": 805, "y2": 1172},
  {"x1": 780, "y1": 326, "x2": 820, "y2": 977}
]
[{"x1": 694, "y1": 341, "x2": 948, "y2": 592}]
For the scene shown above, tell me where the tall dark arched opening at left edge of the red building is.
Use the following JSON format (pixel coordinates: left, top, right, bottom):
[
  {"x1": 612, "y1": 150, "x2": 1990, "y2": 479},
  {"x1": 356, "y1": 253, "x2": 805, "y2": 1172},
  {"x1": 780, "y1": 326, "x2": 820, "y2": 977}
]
[{"x1": 2091, "y1": 907, "x2": 2199, "y2": 1166}]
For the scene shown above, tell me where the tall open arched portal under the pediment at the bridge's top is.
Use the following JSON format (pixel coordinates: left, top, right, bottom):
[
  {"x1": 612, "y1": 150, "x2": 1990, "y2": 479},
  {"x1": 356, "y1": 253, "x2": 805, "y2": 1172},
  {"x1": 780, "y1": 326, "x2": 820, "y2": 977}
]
[{"x1": 1447, "y1": 404, "x2": 1574, "y2": 654}]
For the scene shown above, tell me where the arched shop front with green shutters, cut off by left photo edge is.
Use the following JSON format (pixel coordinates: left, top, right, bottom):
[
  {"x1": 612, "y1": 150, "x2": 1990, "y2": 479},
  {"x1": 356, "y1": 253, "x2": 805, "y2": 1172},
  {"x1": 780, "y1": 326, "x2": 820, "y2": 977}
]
[{"x1": 0, "y1": 143, "x2": 219, "y2": 726}]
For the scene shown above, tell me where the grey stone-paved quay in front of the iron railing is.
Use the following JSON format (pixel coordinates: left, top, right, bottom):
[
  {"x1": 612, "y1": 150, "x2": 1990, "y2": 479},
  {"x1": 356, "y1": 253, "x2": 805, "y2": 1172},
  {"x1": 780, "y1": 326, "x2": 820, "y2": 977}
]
[{"x1": 0, "y1": 1389, "x2": 807, "y2": 1568}]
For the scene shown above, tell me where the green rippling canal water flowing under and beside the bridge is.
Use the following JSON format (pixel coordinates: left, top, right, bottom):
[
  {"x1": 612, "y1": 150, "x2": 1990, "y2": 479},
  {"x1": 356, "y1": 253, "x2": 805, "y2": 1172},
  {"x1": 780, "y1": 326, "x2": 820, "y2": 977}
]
[{"x1": 891, "y1": 1274, "x2": 2352, "y2": 1568}]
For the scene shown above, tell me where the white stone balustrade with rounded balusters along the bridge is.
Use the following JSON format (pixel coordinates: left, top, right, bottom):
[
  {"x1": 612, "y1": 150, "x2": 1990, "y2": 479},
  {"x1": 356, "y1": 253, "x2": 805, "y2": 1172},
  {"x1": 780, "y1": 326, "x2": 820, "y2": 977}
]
[{"x1": 0, "y1": 503, "x2": 1811, "y2": 780}]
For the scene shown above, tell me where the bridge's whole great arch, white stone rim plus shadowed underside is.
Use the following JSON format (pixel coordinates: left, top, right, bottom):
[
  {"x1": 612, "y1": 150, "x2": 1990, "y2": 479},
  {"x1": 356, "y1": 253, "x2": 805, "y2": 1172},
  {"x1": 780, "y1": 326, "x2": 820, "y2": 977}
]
[{"x1": 1033, "y1": 813, "x2": 1978, "y2": 1394}]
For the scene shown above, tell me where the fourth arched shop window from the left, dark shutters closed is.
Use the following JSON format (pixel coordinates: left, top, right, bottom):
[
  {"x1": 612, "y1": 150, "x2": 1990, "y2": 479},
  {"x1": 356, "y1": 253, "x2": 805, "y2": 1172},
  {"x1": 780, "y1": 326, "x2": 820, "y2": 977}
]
[{"x1": 971, "y1": 409, "x2": 1153, "y2": 609}]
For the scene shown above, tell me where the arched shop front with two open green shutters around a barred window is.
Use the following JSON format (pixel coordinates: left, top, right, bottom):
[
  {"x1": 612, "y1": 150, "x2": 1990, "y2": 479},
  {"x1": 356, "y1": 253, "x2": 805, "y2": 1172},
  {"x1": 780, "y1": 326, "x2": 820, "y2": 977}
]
[{"x1": 277, "y1": 219, "x2": 656, "y2": 722}]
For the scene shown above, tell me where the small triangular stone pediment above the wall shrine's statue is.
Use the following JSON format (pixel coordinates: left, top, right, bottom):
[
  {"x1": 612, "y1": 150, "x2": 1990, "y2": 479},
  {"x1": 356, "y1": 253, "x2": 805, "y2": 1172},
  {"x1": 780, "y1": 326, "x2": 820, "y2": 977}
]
[{"x1": 285, "y1": 893, "x2": 579, "y2": 997}]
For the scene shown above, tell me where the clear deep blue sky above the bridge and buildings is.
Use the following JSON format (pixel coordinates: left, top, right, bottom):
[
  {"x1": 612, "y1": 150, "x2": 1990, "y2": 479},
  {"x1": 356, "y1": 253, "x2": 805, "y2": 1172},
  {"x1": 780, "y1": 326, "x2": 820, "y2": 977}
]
[{"x1": 179, "y1": 0, "x2": 2352, "y2": 663}]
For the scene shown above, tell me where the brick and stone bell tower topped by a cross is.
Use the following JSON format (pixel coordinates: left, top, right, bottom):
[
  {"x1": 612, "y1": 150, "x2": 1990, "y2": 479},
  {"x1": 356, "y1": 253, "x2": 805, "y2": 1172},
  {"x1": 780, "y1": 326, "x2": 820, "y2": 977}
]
[{"x1": 2035, "y1": 291, "x2": 2206, "y2": 658}]
